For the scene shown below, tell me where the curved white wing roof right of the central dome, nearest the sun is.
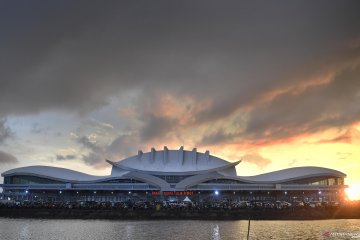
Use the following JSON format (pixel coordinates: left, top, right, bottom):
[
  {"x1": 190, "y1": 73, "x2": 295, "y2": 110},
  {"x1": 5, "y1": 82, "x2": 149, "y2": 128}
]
[{"x1": 241, "y1": 166, "x2": 346, "y2": 182}]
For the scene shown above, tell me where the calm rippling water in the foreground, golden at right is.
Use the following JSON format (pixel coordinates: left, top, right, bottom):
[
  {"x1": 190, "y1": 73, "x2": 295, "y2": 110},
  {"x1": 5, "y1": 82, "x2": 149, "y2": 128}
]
[{"x1": 0, "y1": 218, "x2": 360, "y2": 240}]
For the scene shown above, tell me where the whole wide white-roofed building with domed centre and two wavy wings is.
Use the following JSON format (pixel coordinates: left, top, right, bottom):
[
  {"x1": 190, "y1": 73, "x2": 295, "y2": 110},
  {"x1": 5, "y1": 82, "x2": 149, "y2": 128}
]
[{"x1": 0, "y1": 147, "x2": 346, "y2": 202}]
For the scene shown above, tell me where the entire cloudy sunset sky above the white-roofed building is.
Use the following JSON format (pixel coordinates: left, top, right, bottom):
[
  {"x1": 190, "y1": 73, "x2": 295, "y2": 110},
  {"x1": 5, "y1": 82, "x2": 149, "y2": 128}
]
[{"x1": 0, "y1": 0, "x2": 360, "y2": 199}]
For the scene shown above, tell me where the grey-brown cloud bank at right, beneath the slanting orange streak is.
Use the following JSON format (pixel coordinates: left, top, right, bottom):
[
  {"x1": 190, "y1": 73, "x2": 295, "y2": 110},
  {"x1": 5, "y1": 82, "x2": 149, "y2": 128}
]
[{"x1": 244, "y1": 66, "x2": 360, "y2": 140}]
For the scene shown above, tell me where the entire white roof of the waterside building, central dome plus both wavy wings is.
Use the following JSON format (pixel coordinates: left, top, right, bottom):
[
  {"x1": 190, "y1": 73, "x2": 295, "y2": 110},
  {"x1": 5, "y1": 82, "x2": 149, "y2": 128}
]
[{"x1": 1, "y1": 147, "x2": 346, "y2": 187}]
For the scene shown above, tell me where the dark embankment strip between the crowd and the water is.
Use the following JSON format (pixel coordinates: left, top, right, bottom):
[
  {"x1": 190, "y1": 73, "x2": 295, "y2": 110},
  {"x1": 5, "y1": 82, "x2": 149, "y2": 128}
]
[{"x1": 0, "y1": 207, "x2": 360, "y2": 220}]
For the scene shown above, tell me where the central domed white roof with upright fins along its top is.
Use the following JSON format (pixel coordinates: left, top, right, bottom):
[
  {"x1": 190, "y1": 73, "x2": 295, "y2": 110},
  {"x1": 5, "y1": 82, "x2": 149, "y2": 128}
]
[{"x1": 109, "y1": 147, "x2": 239, "y2": 174}]
